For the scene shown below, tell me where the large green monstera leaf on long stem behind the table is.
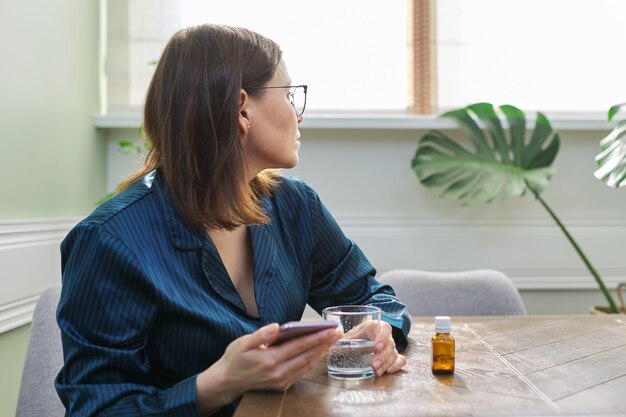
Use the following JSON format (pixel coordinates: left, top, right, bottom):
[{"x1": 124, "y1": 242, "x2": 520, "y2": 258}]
[{"x1": 412, "y1": 103, "x2": 618, "y2": 313}]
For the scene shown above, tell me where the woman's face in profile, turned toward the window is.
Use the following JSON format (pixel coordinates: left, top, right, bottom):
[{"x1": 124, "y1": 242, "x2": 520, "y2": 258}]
[{"x1": 241, "y1": 61, "x2": 302, "y2": 178}]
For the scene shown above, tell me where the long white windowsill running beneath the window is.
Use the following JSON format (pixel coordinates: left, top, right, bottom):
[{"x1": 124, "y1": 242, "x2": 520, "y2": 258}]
[{"x1": 93, "y1": 112, "x2": 613, "y2": 131}]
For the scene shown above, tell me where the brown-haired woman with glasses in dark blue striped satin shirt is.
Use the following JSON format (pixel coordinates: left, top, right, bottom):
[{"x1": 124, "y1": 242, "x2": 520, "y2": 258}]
[{"x1": 56, "y1": 25, "x2": 410, "y2": 416}]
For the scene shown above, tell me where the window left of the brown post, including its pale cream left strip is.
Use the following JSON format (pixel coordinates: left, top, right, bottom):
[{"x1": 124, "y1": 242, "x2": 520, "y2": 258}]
[{"x1": 107, "y1": 0, "x2": 408, "y2": 112}]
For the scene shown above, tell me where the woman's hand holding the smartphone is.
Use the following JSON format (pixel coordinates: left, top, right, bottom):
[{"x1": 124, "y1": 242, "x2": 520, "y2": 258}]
[{"x1": 196, "y1": 323, "x2": 342, "y2": 415}]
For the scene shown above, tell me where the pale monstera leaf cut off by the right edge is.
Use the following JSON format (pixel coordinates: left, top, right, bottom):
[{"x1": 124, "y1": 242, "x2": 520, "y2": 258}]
[{"x1": 594, "y1": 103, "x2": 626, "y2": 188}]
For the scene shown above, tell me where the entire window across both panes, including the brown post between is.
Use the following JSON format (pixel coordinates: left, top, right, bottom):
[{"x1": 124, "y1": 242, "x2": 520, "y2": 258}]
[{"x1": 106, "y1": 0, "x2": 626, "y2": 114}]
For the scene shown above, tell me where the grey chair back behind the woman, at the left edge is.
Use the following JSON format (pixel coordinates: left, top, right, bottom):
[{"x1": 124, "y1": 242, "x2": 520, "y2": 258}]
[{"x1": 15, "y1": 286, "x2": 65, "y2": 417}]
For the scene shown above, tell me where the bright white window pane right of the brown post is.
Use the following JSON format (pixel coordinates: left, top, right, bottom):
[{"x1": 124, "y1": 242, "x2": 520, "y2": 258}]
[{"x1": 436, "y1": 0, "x2": 626, "y2": 112}]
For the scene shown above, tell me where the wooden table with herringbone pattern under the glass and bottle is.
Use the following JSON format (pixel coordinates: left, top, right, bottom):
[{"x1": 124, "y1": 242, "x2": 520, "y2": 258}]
[{"x1": 235, "y1": 315, "x2": 626, "y2": 417}]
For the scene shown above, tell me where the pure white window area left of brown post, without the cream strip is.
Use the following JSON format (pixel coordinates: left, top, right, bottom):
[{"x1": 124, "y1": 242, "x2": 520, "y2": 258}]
[{"x1": 181, "y1": 0, "x2": 408, "y2": 111}]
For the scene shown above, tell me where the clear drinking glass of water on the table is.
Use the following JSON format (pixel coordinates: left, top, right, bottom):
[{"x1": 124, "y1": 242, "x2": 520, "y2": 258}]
[{"x1": 322, "y1": 306, "x2": 381, "y2": 379}]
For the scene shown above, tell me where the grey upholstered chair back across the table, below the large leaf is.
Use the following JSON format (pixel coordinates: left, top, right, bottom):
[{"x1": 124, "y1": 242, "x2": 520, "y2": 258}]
[{"x1": 379, "y1": 269, "x2": 526, "y2": 316}]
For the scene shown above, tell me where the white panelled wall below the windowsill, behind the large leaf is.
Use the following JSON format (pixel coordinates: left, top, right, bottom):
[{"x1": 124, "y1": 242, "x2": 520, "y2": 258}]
[{"x1": 108, "y1": 128, "x2": 626, "y2": 314}]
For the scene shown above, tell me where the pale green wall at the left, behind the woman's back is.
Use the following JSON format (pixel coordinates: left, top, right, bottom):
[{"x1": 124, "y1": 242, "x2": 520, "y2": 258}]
[{"x1": 0, "y1": 0, "x2": 106, "y2": 416}]
